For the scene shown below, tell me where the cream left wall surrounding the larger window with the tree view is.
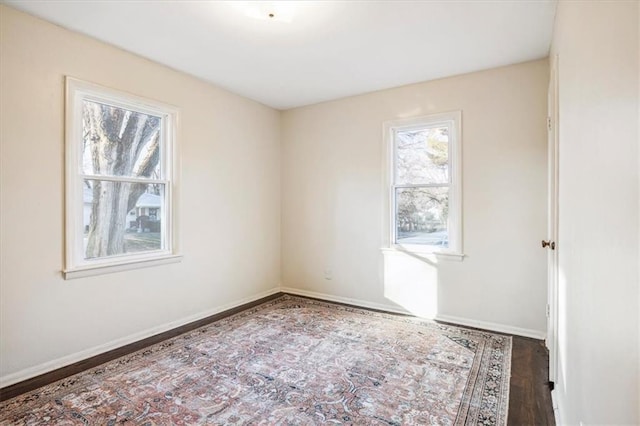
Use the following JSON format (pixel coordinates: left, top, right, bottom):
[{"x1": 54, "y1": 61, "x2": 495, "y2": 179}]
[{"x1": 0, "y1": 5, "x2": 280, "y2": 386}]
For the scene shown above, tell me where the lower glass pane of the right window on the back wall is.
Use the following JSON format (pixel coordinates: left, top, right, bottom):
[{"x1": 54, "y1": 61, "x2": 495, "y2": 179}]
[{"x1": 395, "y1": 187, "x2": 449, "y2": 248}]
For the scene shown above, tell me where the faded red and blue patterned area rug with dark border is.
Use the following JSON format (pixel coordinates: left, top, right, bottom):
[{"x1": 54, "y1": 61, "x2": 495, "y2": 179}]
[{"x1": 0, "y1": 295, "x2": 511, "y2": 425}]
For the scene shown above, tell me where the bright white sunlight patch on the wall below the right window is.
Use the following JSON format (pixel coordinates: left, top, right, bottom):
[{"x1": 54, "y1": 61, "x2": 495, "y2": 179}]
[{"x1": 383, "y1": 249, "x2": 438, "y2": 319}]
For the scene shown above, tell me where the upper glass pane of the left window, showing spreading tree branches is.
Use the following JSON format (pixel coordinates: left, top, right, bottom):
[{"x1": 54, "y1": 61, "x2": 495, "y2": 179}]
[{"x1": 82, "y1": 100, "x2": 162, "y2": 179}]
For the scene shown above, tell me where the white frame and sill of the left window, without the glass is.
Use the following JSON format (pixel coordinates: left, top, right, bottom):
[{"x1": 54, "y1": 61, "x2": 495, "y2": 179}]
[{"x1": 62, "y1": 77, "x2": 182, "y2": 279}]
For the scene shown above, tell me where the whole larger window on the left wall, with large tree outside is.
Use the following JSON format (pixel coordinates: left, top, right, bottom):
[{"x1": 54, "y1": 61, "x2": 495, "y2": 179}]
[{"x1": 64, "y1": 78, "x2": 179, "y2": 278}]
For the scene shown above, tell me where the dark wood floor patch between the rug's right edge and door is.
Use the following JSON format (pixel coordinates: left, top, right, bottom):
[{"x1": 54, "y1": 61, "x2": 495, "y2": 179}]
[{"x1": 508, "y1": 336, "x2": 556, "y2": 426}]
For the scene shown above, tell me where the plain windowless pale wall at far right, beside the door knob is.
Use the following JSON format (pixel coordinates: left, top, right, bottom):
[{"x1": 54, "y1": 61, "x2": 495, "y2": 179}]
[{"x1": 552, "y1": 1, "x2": 640, "y2": 424}]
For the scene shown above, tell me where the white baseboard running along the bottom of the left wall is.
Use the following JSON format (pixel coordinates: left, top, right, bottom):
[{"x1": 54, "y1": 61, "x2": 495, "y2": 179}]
[{"x1": 0, "y1": 287, "x2": 280, "y2": 388}]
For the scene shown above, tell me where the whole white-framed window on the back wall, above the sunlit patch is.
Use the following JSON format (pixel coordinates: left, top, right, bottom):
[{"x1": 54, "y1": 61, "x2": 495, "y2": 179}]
[{"x1": 385, "y1": 111, "x2": 462, "y2": 257}]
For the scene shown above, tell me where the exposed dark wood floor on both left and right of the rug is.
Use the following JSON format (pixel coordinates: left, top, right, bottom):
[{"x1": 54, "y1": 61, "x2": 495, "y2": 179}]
[{"x1": 0, "y1": 293, "x2": 555, "y2": 426}]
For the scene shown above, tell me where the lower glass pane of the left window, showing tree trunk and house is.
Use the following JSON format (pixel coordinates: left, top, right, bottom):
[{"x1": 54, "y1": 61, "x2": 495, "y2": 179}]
[{"x1": 83, "y1": 179, "x2": 165, "y2": 259}]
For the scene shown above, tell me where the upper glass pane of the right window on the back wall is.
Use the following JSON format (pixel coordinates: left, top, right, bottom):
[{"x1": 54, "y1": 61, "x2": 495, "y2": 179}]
[{"x1": 395, "y1": 127, "x2": 449, "y2": 185}]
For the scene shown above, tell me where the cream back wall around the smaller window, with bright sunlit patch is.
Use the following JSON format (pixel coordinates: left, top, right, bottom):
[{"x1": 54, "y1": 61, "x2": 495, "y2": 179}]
[{"x1": 282, "y1": 60, "x2": 548, "y2": 336}]
